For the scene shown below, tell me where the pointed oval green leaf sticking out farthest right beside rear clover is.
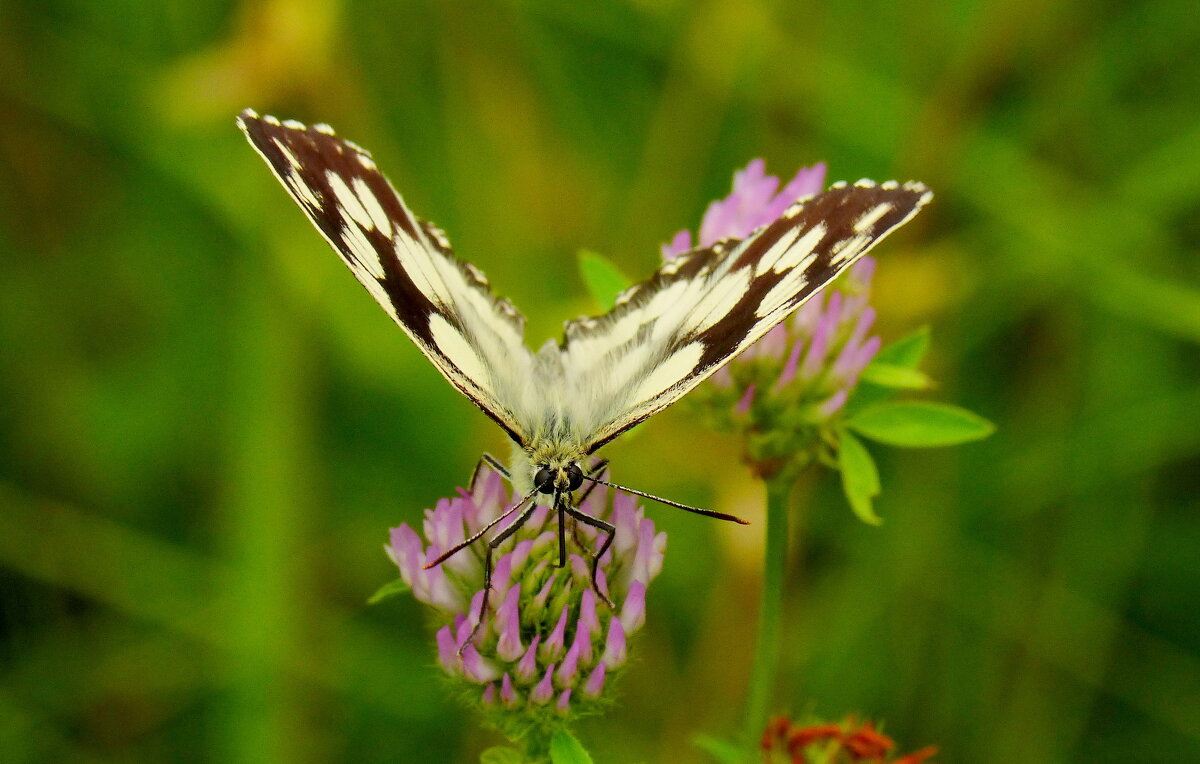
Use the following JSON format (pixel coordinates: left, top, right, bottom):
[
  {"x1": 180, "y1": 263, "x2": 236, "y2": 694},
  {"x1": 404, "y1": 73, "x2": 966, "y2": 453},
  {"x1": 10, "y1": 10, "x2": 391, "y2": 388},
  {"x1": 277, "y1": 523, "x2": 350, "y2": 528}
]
[{"x1": 846, "y1": 401, "x2": 996, "y2": 449}]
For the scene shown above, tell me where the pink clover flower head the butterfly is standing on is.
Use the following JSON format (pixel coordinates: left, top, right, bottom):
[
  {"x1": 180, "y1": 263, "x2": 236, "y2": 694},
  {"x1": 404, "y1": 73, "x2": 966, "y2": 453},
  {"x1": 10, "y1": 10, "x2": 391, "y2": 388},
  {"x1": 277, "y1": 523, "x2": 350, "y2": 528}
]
[{"x1": 386, "y1": 468, "x2": 666, "y2": 728}]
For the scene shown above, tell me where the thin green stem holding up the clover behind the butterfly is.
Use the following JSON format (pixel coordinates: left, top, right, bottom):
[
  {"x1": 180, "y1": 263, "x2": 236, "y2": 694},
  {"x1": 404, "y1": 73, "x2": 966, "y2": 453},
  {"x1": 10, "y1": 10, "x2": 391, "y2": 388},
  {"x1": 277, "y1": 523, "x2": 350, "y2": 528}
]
[{"x1": 744, "y1": 470, "x2": 793, "y2": 745}]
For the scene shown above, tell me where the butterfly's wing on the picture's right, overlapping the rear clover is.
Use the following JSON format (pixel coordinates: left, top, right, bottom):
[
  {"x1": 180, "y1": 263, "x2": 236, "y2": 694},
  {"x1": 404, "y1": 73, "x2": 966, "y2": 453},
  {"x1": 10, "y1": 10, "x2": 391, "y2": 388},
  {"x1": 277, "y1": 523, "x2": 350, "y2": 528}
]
[{"x1": 562, "y1": 181, "x2": 932, "y2": 453}]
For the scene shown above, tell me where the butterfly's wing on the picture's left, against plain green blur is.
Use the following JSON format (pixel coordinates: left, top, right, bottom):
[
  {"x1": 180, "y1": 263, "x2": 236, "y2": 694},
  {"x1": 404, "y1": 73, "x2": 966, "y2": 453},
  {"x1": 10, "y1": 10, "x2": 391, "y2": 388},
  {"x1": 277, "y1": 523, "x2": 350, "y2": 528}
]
[{"x1": 238, "y1": 109, "x2": 536, "y2": 445}]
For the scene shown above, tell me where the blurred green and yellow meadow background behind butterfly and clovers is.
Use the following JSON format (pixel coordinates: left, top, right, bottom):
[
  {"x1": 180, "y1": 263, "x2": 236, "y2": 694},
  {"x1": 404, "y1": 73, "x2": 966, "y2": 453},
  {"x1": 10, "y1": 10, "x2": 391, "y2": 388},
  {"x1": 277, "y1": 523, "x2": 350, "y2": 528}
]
[{"x1": 0, "y1": 0, "x2": 1200, "y2": 764}]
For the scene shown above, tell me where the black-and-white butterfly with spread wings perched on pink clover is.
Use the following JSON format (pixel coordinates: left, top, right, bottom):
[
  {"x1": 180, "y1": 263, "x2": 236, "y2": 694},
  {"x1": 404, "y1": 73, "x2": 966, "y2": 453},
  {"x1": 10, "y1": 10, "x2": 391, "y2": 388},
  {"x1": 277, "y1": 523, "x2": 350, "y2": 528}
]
[{"x1": 238, "y1": 109, "x2": 932, "y2": 642}]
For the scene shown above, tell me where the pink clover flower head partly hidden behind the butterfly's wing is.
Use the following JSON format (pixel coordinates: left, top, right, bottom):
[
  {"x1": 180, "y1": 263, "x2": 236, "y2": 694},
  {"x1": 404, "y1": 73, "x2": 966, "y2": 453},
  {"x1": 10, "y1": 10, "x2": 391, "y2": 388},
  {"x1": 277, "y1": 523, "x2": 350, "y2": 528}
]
[{"x1": 662, "y1": 160, "x2": 881, "y2": 475}]
